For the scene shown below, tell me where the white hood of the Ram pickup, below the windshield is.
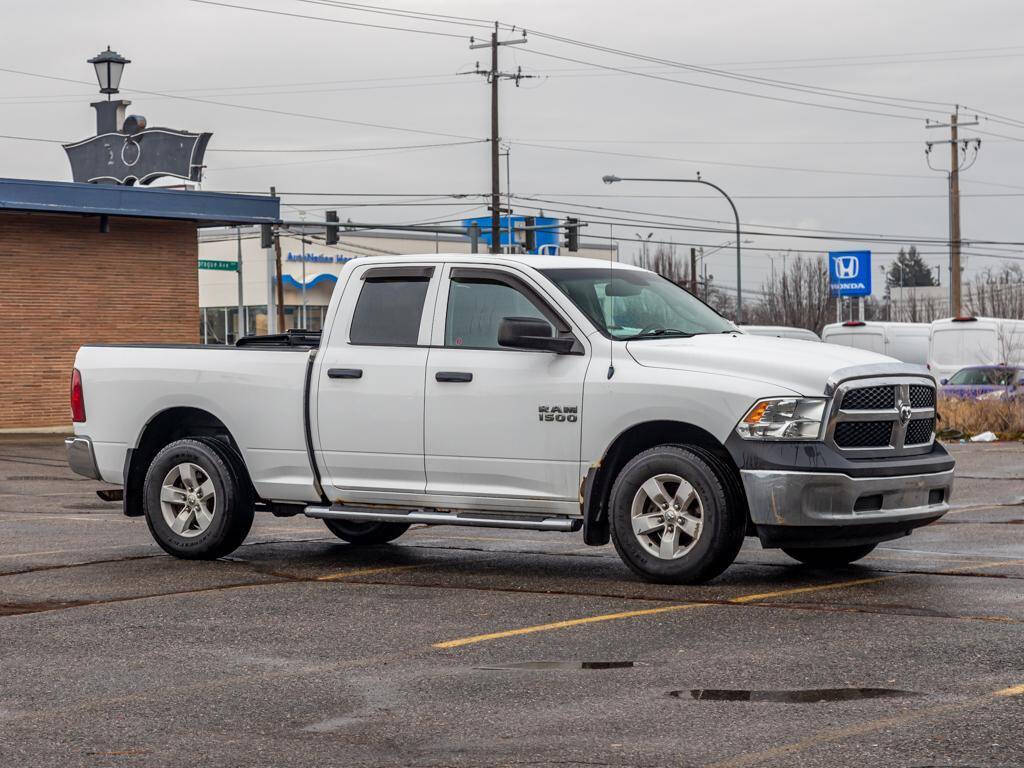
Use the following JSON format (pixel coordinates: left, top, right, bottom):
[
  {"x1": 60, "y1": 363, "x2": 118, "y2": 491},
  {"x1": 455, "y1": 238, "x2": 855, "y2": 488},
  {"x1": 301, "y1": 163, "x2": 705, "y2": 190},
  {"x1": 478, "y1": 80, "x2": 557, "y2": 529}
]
[{"x1": 626, "y1": 333, "x2": 901, "y2": 395}]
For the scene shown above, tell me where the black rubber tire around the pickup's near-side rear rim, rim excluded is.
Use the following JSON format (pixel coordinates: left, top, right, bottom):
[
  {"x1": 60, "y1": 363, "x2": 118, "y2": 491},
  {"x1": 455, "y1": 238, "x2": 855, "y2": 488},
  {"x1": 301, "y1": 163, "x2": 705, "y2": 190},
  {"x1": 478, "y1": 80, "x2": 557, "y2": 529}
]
[{"x1": 142, "y1": 437, "x2": 254, "y2": 560}]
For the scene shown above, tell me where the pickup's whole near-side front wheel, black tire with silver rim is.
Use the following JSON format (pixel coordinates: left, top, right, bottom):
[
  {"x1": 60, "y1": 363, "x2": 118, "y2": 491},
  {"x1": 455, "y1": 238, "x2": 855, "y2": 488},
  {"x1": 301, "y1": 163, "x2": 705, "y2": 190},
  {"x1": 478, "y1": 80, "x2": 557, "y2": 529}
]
[{"x1": 608, "y1": 445, "x2": 746, "y2": 584}]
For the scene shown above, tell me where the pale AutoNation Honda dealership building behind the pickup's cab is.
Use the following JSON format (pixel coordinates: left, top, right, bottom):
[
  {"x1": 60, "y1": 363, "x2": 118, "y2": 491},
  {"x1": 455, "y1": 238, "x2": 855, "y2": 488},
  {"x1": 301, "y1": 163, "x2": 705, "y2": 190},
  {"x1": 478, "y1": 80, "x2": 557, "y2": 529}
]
[{"x1": 199, "y1": 226, "x2": 617, "y2": 344}]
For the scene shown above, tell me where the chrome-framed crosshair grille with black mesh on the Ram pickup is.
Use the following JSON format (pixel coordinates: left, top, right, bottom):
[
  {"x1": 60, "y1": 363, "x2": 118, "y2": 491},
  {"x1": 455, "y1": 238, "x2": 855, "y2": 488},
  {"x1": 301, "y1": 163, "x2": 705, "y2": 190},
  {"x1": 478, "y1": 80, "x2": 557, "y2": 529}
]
[{"x1": 825, "y1": 375, "x2": 935, "y2": 458}]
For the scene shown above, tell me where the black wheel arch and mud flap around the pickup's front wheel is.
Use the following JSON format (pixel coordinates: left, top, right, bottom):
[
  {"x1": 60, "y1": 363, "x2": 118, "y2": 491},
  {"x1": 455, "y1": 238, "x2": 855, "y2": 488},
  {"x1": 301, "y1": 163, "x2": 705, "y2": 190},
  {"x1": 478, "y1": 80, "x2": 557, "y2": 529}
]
[{"x1": 582, "y1": 420, "x2": 753, "y2": 546}]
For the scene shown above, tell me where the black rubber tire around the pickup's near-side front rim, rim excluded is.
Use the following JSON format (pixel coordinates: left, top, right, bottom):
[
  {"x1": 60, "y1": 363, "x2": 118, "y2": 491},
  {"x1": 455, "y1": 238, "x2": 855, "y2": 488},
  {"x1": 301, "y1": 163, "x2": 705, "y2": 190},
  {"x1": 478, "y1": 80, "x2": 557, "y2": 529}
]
[{"x1": 608, "y1": 445, "x2": 746, "y2": 584}]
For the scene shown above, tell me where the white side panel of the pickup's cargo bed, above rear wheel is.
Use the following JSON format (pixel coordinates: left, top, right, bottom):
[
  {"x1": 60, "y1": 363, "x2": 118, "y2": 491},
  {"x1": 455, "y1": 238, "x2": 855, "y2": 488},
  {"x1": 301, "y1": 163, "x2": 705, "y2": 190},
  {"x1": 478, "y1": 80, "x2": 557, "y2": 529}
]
[{"x1": 75, "y1": 346, "x2": 316, "y2": 501}]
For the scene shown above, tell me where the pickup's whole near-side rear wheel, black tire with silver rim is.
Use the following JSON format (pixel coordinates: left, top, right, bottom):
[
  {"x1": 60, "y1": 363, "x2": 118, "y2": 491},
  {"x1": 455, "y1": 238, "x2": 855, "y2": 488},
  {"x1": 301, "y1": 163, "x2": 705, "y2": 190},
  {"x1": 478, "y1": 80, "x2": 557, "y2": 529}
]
[{"x1": 143, "y1": 438, "x2": 253, "y2": 560}]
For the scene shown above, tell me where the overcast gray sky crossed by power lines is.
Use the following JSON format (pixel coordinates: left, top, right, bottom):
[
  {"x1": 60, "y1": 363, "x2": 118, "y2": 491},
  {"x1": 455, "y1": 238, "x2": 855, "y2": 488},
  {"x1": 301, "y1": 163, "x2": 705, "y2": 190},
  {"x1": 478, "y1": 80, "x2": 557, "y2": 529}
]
[{"x1": 0, "y1": 0, "x2": 1024, "y2": 296}]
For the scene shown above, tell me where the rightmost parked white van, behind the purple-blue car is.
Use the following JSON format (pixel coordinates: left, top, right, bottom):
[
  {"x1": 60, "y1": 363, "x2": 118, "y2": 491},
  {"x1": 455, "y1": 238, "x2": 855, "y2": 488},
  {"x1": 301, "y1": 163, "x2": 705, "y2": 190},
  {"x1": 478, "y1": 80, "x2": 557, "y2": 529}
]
[{"x1": 928, "y1": 317, "x2": 1024, "y2": 382}]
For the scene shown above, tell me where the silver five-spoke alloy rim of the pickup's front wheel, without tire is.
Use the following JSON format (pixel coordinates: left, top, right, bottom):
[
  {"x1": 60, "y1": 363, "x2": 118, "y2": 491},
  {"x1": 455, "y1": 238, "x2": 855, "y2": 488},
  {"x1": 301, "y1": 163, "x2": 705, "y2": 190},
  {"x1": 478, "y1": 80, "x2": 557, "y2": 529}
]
[{"x1": 630, "y1": 474, "x2": 703, "y2": 560}]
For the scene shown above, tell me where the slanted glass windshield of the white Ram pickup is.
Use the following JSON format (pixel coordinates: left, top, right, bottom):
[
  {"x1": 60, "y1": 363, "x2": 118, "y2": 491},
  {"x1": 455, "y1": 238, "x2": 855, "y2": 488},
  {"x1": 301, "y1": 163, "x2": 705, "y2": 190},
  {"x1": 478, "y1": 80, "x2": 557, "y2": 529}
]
[{"x1": 542, "y1": 267, "x2": 736, "y2": 339}]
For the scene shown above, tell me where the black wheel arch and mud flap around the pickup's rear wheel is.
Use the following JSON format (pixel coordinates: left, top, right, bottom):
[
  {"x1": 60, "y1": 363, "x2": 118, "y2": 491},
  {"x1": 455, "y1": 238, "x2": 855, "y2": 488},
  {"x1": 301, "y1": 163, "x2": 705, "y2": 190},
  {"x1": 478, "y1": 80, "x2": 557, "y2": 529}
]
[{"x1": 124, "y1": 406, "x2": 259, "y2": 517}]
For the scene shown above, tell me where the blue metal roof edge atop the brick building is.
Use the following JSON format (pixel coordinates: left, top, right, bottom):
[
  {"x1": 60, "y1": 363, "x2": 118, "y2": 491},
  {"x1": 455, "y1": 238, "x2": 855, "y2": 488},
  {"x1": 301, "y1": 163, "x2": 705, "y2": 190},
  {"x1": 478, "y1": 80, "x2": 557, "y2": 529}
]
[{"x1": 0, "y1": 178, "x2": 281, "y2": 225}]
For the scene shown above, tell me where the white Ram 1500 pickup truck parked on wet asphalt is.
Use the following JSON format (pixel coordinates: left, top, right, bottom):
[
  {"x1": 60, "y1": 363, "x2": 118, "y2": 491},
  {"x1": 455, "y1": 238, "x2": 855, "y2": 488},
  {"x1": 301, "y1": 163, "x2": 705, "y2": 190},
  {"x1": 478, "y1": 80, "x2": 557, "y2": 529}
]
[{"x1": 68, "y1": 254, "x2": 953, "y2": 583}]
